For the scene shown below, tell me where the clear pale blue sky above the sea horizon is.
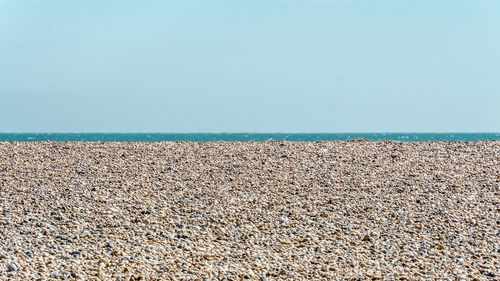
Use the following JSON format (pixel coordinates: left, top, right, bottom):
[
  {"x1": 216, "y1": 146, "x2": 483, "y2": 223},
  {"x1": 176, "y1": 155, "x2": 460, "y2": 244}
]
[{"x1": 0, "y1": 0, "x2": 500, "y2": 132}]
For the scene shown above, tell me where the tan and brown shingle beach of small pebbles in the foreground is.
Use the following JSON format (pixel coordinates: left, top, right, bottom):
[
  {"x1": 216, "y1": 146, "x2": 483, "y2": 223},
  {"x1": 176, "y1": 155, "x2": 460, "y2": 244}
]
[{"x1": 0, "y1": 140, "x2": 500, "y2": 281}]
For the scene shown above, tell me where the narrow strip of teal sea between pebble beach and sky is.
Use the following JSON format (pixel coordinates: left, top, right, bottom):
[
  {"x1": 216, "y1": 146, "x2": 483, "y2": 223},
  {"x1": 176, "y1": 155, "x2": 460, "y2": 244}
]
[{"x1": 0, "y1": 133, "x2": 500, "y2": 142}]
